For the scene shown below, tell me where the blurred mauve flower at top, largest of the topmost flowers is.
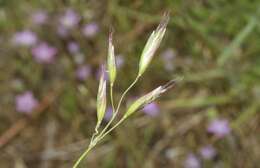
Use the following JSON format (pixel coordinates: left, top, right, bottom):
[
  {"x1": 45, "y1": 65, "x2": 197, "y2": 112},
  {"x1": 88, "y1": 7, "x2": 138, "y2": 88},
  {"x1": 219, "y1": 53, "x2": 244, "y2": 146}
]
[{"x1": 60, "y1": 9, "x2": 80, "y2": 29}]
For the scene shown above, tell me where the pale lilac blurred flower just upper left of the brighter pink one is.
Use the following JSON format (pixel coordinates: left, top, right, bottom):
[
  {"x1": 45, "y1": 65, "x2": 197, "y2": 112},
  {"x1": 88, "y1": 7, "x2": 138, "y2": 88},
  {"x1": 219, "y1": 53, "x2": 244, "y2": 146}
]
[{"x1": 12, "y1": 30, "x2": 37, "y2": 46}]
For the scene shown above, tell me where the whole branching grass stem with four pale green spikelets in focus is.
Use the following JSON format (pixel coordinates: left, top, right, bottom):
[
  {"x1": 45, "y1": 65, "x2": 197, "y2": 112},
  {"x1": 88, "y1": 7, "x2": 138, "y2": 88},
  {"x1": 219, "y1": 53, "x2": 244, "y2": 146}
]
[{"x1": 73, "y1": 13, "x2": 179, "y2": 168}]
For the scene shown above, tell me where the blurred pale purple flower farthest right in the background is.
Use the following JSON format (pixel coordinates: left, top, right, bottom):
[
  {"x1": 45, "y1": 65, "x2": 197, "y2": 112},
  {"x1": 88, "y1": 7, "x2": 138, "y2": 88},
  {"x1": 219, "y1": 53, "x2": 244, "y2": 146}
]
[{"x1": 208, "y1": 119, "x2": 230, "y2": 138}]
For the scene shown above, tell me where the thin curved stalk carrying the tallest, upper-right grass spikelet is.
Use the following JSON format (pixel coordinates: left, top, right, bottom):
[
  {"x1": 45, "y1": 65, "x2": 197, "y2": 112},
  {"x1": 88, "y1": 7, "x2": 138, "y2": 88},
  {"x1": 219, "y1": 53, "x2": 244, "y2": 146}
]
[{"x1": 98, "y1": 76, "x2": 140, "y2": 137}]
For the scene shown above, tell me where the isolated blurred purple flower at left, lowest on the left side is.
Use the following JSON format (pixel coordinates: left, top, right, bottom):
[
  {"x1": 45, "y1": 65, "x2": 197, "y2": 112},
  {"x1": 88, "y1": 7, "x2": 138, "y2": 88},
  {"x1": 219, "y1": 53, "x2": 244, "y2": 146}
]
[{"x1": 15, "y1": 91, "x2": 38, "y2": 114}]
